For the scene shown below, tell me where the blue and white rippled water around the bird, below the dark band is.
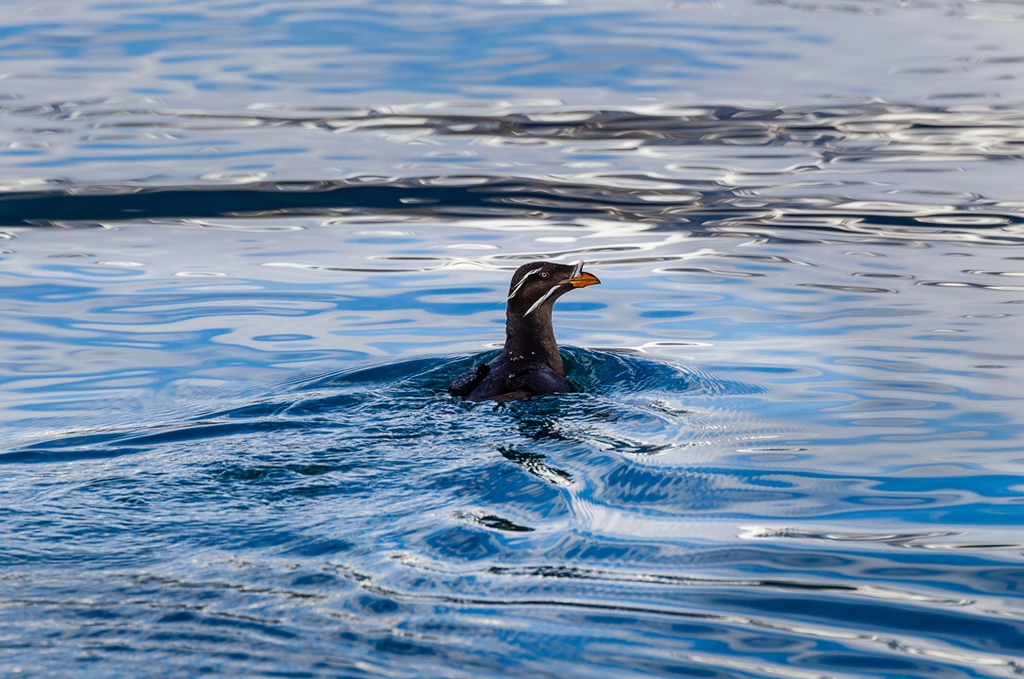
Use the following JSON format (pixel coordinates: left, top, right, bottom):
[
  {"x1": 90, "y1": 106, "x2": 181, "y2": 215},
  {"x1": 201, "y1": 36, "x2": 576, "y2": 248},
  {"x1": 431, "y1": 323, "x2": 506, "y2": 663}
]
[{"x1": 0, "y1": 209, "x2": 1024, "y2": 676}]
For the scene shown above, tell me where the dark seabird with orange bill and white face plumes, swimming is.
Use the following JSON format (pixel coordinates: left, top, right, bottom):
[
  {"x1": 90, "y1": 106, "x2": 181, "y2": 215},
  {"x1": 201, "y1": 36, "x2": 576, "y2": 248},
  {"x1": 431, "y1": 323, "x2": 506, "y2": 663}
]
[{"x1": 449, "y1": 262, "x2": 600, "y2": 401}]
